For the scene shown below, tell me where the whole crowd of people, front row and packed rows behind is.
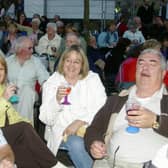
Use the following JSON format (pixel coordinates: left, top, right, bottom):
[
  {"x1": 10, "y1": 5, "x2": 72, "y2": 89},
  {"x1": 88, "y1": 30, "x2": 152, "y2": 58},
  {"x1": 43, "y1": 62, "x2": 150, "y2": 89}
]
[{"x1": 0, "y1": 0, "x2": 168, "y2": 168}]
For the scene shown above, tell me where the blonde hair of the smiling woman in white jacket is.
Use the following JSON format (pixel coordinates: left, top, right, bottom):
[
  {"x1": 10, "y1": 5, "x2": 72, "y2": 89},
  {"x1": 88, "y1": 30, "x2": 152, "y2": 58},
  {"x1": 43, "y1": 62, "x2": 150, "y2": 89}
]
[{"x1": 57, "y1": 45, "x2": 89, "y2": 79}]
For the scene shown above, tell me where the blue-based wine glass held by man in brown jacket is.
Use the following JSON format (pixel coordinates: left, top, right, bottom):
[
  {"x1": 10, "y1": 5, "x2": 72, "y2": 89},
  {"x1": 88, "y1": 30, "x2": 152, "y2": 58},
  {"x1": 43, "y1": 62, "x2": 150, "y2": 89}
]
[{"x1": 125, "y1": 99, "x2": 141, "y2": 133}]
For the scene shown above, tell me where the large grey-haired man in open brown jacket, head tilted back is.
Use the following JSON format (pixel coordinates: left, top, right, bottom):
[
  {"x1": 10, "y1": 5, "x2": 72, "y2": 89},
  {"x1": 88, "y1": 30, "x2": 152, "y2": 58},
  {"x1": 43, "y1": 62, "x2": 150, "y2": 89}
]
[{"x1": 85, "y1": 49, "x2": 168, "y2": 168}]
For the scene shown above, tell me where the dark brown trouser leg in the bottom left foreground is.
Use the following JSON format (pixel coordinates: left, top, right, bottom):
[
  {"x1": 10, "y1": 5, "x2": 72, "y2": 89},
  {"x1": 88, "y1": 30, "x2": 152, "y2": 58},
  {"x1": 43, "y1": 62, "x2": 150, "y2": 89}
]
[{"x1": 2, "y1": 122, "x2": 57, "y2": 168}]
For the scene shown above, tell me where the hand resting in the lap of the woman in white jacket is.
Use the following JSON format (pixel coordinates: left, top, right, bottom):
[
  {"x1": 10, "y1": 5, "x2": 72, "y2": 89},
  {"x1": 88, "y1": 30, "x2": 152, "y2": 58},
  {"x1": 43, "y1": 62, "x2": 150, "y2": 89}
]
[{"x1": 63, "y1": 120, "x2": 86, "y2": 136}]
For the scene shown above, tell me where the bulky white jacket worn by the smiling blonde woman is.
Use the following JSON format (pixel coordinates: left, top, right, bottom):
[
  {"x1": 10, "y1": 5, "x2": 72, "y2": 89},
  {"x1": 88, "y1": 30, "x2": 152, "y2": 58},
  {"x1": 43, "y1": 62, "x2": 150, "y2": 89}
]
[{"x1": 39, "y1": 71, "x2": 106, "y2": 155}]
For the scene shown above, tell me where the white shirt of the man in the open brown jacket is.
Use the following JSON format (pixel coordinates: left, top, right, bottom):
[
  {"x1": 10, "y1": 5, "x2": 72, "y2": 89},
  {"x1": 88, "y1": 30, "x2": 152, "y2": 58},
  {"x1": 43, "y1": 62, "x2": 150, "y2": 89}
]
[{"x1": 110, "y1": 86, "x2": 168, "y2": 163}]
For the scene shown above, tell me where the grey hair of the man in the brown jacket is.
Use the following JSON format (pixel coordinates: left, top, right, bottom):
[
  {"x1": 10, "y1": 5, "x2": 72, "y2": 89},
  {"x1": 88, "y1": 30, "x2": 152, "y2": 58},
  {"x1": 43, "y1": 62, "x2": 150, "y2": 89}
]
[{"x1": 139, "y1": 48, "x2": 167, "y2": 70}]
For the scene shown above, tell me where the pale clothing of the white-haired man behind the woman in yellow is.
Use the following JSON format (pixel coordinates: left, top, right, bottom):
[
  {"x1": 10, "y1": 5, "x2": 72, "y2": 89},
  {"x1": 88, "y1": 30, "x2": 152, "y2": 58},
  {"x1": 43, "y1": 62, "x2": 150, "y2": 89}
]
[{"x1": 7, "y1": 54, "x2": 49, "y2": 123}]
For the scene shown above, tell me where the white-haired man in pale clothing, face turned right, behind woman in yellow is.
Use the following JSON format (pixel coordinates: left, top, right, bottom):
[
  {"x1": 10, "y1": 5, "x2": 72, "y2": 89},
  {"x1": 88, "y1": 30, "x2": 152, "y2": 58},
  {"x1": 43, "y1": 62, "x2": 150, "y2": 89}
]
[{"x1": 6, "y1": 36, "x2": 49, "y2": 123}]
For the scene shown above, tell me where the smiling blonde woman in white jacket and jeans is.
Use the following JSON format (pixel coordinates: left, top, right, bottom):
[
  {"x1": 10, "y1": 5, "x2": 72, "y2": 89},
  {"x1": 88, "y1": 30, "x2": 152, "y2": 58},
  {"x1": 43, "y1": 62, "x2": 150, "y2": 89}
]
[{"x1": 40, "y1": 45, "x2": 106, "y2": 168}]
